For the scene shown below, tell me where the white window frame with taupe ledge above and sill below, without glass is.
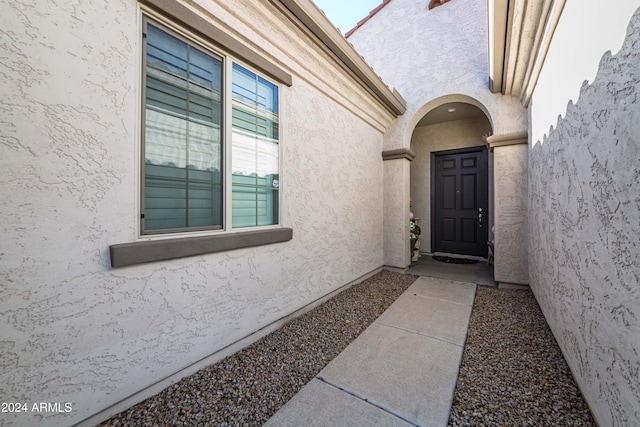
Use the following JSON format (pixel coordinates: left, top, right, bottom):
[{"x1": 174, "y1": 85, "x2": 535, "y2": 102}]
[{"x1": 109, "y1": 6, "x2": 293, "y2": 268}]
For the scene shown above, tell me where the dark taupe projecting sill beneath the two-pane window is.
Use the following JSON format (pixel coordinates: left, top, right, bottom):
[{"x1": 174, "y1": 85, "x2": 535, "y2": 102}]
[{"x1": 109, "y1": 228, "x2": 293, "y2": 268}]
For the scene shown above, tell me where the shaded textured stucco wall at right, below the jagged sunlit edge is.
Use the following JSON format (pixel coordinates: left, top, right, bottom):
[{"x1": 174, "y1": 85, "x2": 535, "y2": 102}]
[{"x1": 529, "y1": 9, "x2": 640, "y2": 426}]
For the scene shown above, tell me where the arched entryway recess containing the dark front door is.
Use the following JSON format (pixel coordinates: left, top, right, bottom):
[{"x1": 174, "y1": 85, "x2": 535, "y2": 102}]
[{"x1": 410, "y1": 96, "x2": 493, "y2": 258}]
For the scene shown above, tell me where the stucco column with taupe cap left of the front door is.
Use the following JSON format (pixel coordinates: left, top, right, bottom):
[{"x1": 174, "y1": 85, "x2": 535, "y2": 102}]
[{"x1": 382, "y1": 148, "x2": 416, "y2": 268}]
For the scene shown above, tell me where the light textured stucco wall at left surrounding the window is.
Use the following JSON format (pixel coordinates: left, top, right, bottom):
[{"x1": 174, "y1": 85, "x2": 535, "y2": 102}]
[{"x1": 0, "y1": 0, "x2": 392, "y2": 426}]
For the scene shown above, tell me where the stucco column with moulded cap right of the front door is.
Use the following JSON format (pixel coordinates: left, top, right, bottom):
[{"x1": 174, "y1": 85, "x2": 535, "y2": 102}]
[{"x1": 487, "y1": 132, "x2": 529, "y2": 285}]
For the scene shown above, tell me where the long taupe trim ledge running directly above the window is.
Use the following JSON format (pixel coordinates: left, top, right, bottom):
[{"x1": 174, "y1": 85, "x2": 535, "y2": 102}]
[{"x1": 140, "y1": 0, "x2": 293, "y2": 86}]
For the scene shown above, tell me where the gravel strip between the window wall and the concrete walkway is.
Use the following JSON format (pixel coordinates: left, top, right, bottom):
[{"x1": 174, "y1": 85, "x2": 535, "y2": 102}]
[{"x1": 102, "y1": 270, "x2": 416, "y2": 426}]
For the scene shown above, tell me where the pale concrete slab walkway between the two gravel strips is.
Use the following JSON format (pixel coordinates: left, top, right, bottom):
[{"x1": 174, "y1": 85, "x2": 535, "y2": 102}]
[{"x1": 265, "y1": 277, "x2": 476, "y2": 427}]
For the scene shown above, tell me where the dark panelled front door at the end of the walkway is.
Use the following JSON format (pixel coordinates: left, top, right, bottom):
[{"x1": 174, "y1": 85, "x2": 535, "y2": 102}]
[{"x1": 431, "y1": 147, "x2": 488, "y2": 257}]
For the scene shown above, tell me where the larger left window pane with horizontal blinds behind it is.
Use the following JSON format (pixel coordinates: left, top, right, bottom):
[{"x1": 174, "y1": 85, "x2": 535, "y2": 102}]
[{"x1": 143, "y1": 23, "x2": 223, "y2": 231}]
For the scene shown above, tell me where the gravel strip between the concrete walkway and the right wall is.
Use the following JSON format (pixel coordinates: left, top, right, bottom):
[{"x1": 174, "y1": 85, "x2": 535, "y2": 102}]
[{"x1": 449, "y1": 287, "x2": 596, "y2": 427}]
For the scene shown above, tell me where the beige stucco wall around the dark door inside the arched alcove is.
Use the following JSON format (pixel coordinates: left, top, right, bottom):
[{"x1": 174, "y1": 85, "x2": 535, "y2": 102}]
[{"x1": 411, "y1": 117, "x2": 491, "y2": 252}]
